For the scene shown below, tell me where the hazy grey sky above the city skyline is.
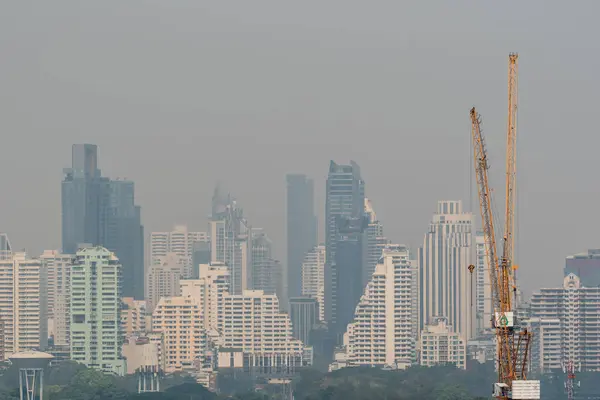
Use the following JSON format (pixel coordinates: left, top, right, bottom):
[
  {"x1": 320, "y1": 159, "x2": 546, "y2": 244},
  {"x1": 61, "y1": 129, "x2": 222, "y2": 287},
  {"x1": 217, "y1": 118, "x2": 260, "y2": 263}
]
[{"x1": 0, "y1": 0, "x2": 600, "y2": 291}]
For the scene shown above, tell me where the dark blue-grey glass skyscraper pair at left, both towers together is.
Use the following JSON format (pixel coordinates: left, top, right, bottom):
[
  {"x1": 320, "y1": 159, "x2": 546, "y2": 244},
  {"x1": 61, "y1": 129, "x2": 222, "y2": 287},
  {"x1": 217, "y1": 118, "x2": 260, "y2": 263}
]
[{"x1": 62, "y1": 144, "x2": 144, "y2": 300}]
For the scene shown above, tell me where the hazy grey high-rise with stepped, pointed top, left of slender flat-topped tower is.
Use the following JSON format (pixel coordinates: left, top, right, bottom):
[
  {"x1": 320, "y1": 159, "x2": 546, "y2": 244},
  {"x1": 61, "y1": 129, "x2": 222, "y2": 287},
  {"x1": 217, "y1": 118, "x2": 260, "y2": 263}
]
[{"x1": 209, "y1": 192, "x2": 253, "y2": 294}]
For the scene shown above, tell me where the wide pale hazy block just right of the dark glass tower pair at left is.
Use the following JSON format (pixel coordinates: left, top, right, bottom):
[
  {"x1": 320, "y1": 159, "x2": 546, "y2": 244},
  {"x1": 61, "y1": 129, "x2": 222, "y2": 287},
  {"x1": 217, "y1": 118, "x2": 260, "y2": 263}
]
[{"x1": 149, "y1": 225, "x2": 210, "y2": 278}]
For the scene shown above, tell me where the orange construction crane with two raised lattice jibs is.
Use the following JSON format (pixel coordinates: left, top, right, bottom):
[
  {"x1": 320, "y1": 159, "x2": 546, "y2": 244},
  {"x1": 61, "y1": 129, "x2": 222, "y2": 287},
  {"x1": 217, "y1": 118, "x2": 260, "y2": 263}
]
[{"x1": 470, "y1": 54, "x2": 539, "y2": 399}]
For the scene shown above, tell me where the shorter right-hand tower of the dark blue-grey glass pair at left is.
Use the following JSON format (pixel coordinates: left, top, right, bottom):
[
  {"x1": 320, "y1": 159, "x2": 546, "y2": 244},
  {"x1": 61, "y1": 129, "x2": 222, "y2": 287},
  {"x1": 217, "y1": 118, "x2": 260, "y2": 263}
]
[{"x1": 101, "y1": 180, "x2": 145, "y2": 300}]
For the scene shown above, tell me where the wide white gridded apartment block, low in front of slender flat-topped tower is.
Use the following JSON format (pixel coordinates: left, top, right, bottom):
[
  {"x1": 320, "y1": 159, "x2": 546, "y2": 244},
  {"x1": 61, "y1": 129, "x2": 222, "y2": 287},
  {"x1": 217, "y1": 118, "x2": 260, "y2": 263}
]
[{"x1": 221, "y1": 290, "x2": 304, "y2": 365}]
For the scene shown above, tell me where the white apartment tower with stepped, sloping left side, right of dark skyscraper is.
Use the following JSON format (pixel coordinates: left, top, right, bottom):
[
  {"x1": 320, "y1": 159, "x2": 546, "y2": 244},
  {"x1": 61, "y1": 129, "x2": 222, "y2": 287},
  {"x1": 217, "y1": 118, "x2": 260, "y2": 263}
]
[{"x1": 344, "y1": 245, "x2": 416, "y2": 369}]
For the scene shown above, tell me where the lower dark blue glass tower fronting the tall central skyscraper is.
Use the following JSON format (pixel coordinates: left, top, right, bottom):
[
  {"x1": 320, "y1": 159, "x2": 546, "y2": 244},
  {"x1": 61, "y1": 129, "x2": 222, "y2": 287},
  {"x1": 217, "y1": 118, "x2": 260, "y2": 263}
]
[{"x1": 329, "y1": 216, "x2": 368, "y2": 336}]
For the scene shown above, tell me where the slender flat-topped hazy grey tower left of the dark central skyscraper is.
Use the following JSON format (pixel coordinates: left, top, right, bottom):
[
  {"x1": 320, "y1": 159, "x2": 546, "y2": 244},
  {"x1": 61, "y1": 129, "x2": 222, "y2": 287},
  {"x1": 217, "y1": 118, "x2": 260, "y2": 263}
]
[{"x1": 286, "y1": 174, "x2": 317, "y2": 297}]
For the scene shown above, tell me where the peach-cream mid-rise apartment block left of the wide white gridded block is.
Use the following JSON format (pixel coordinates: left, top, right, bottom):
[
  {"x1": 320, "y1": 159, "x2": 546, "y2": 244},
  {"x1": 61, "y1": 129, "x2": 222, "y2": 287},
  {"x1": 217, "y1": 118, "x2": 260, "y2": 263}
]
[{"x1": 152, "y1": 296, "x2": 207, "y2": 372}]
